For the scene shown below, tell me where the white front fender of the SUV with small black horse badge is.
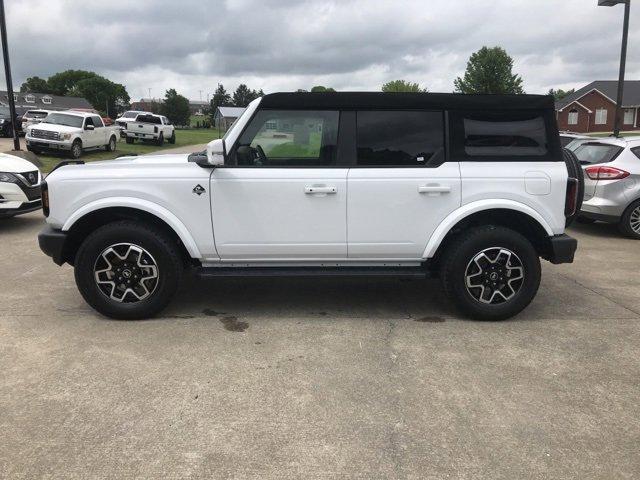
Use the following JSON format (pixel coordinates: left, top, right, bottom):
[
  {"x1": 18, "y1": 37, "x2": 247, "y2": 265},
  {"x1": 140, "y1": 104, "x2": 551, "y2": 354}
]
[{"x1": 47, "y1": 160, "x2": 218, "y2": 259}]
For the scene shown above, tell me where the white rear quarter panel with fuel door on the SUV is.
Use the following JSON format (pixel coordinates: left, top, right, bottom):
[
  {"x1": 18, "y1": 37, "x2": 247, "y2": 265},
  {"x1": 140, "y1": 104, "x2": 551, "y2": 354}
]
[{"x1": 460, "y1": 162, "x2": 568, "y2": 235}]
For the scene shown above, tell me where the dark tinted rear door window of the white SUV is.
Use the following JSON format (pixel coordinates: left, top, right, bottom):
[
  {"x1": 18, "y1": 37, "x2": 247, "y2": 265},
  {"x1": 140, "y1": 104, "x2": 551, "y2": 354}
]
[{"x1": 357, "y1": 111, "x2": 444, "y2": 166}]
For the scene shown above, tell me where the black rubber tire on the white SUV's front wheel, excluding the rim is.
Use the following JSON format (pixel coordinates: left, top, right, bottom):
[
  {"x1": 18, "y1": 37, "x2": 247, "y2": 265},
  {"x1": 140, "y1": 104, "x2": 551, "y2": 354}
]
[{"x1": 74, "y1": 220, "x2": 184, "y2": 320}]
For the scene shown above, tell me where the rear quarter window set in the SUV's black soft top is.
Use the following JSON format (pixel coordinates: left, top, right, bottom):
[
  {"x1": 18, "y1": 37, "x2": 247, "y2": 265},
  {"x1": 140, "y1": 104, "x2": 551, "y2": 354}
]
[{"x1": 464, "y1": 116, "x2": 547, "y2": 157}]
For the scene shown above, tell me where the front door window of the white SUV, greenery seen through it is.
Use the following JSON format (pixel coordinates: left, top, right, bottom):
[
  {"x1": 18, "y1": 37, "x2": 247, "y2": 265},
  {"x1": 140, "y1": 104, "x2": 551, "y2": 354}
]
[{"x1": 232, "y1": 110, "x2": 340, "y2": 167}]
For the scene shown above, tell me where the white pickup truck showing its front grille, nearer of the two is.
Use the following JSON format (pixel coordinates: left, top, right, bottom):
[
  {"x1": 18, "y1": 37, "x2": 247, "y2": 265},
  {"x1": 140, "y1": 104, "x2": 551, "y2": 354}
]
[{"x1": 25, "y1": 110, "x2": 119, "y2": 158}]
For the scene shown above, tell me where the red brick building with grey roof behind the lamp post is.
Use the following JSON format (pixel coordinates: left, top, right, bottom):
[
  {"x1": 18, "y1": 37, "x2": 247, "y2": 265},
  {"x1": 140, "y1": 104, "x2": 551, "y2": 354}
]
[{"x1": 556, "y1": 80, "x2": 640, "y2": 133}]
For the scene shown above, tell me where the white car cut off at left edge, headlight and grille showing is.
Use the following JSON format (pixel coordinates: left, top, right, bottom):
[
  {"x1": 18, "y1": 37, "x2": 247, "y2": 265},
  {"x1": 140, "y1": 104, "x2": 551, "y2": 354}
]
[{"x1": 0, "y1": 153, "x2": 42, "y2": 218}]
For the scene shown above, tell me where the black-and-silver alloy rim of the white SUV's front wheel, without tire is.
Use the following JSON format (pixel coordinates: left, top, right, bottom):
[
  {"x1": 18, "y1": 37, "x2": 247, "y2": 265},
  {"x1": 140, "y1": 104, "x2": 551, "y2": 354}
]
[{"x1": 93, "y1": 243, "x2": 159, "y2": 303}]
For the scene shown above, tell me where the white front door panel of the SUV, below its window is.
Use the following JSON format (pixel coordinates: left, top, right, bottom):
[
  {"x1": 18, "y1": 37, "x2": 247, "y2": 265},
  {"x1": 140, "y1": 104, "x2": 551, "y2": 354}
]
[{"x1": 211, "y1": 168, "x2": 347, "y2": 261}]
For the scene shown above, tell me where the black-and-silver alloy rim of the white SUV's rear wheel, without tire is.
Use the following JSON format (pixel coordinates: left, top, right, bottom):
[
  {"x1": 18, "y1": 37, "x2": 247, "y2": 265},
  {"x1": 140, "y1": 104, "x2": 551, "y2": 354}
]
[{"x1": 465, "y1": 247, "x2": 524, "y2": 305}]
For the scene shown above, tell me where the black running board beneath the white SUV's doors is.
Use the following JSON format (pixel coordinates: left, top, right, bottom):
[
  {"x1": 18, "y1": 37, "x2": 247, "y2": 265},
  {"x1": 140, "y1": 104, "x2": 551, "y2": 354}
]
[{"x1": 196, "y1": 266, "x2": 429, "y2": 278}]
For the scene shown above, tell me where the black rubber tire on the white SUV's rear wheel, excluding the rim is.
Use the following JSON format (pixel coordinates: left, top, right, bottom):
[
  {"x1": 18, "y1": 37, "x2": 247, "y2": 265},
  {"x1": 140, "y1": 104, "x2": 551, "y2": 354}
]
[{"x1": 440, "y1": 225, "x2": 541, "y2": 320}]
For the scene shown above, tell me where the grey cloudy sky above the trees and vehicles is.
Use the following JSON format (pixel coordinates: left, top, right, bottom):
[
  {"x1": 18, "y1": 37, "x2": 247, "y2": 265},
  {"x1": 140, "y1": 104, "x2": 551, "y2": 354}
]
[{"x1": 2, "y1": 0, "x2": 640, "y2": 100}]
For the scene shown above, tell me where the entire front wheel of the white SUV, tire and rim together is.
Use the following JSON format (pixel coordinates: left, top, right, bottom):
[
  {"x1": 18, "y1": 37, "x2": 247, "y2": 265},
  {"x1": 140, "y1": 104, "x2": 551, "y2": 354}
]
[{"x1": 74, "y1": 220, "x2": 183, "y2": 320}]
